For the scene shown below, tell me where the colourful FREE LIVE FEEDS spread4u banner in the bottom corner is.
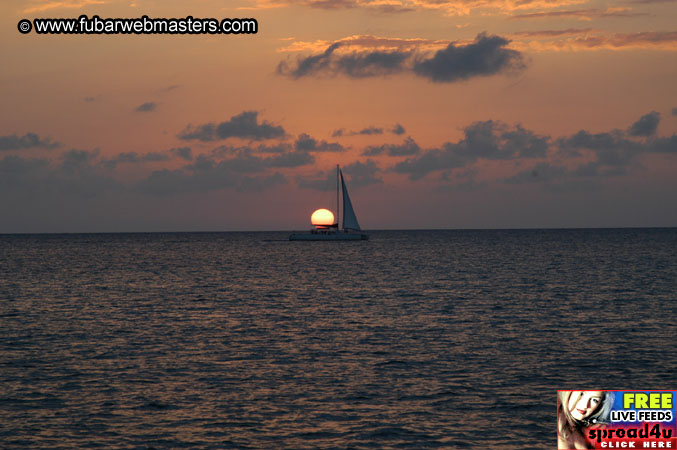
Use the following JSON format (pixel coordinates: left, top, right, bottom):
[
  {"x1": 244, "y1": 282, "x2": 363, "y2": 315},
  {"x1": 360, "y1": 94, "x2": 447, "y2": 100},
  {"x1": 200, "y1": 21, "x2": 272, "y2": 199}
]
[{"x1": 557, "y1": 390, "x2": 677, "y2": 450}]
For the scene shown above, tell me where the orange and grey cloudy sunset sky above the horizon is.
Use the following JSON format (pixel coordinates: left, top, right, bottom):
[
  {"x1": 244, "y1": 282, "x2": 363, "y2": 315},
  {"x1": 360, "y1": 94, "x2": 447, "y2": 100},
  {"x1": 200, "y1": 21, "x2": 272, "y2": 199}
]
[{"x1": 0, "y1": 0, "x2": 677, "y2": 233}]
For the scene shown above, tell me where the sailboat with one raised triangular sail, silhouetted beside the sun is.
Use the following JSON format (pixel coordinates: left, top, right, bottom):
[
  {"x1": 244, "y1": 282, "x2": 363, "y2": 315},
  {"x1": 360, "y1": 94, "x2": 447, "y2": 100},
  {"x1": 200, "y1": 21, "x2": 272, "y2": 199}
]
[{"x1": 289, "y1": 165, "x2": 369, "y2": 241}]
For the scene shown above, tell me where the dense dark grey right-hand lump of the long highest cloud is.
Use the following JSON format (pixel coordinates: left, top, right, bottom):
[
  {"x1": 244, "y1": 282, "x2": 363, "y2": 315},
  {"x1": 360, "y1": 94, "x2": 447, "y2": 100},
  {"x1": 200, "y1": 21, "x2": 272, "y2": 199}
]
[{"x1": 414, "y1": 33, "x2": 525, "y2": 83}]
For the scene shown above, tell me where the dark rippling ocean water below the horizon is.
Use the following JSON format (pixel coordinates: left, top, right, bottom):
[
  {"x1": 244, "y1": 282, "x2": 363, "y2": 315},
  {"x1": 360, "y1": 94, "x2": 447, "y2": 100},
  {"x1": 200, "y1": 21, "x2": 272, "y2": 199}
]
[{"x1": 0, "y1": 229, "x2": 677, "y2": 449}]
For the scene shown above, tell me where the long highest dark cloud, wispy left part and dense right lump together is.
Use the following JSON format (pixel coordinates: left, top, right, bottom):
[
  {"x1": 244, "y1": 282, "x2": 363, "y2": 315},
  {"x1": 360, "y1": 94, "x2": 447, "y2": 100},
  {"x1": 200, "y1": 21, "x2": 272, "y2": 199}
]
[{"x1": 277, "y1": 33, "x2": 525, "y2": 83}]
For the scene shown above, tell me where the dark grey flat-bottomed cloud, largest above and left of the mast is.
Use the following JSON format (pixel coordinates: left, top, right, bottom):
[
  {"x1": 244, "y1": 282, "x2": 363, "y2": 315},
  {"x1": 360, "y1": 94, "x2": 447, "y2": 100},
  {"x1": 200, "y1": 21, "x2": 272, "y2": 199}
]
[{"x1": 179, "y1": 111, "x2": 285, "y2": 142}]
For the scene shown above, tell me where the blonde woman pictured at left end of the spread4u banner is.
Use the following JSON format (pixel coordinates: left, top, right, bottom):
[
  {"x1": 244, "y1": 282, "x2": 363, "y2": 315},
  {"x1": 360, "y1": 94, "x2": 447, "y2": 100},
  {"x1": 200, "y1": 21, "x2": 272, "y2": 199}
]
[{"x1": 557, "y1": 391, "x2": 614, "y2": 450}]
